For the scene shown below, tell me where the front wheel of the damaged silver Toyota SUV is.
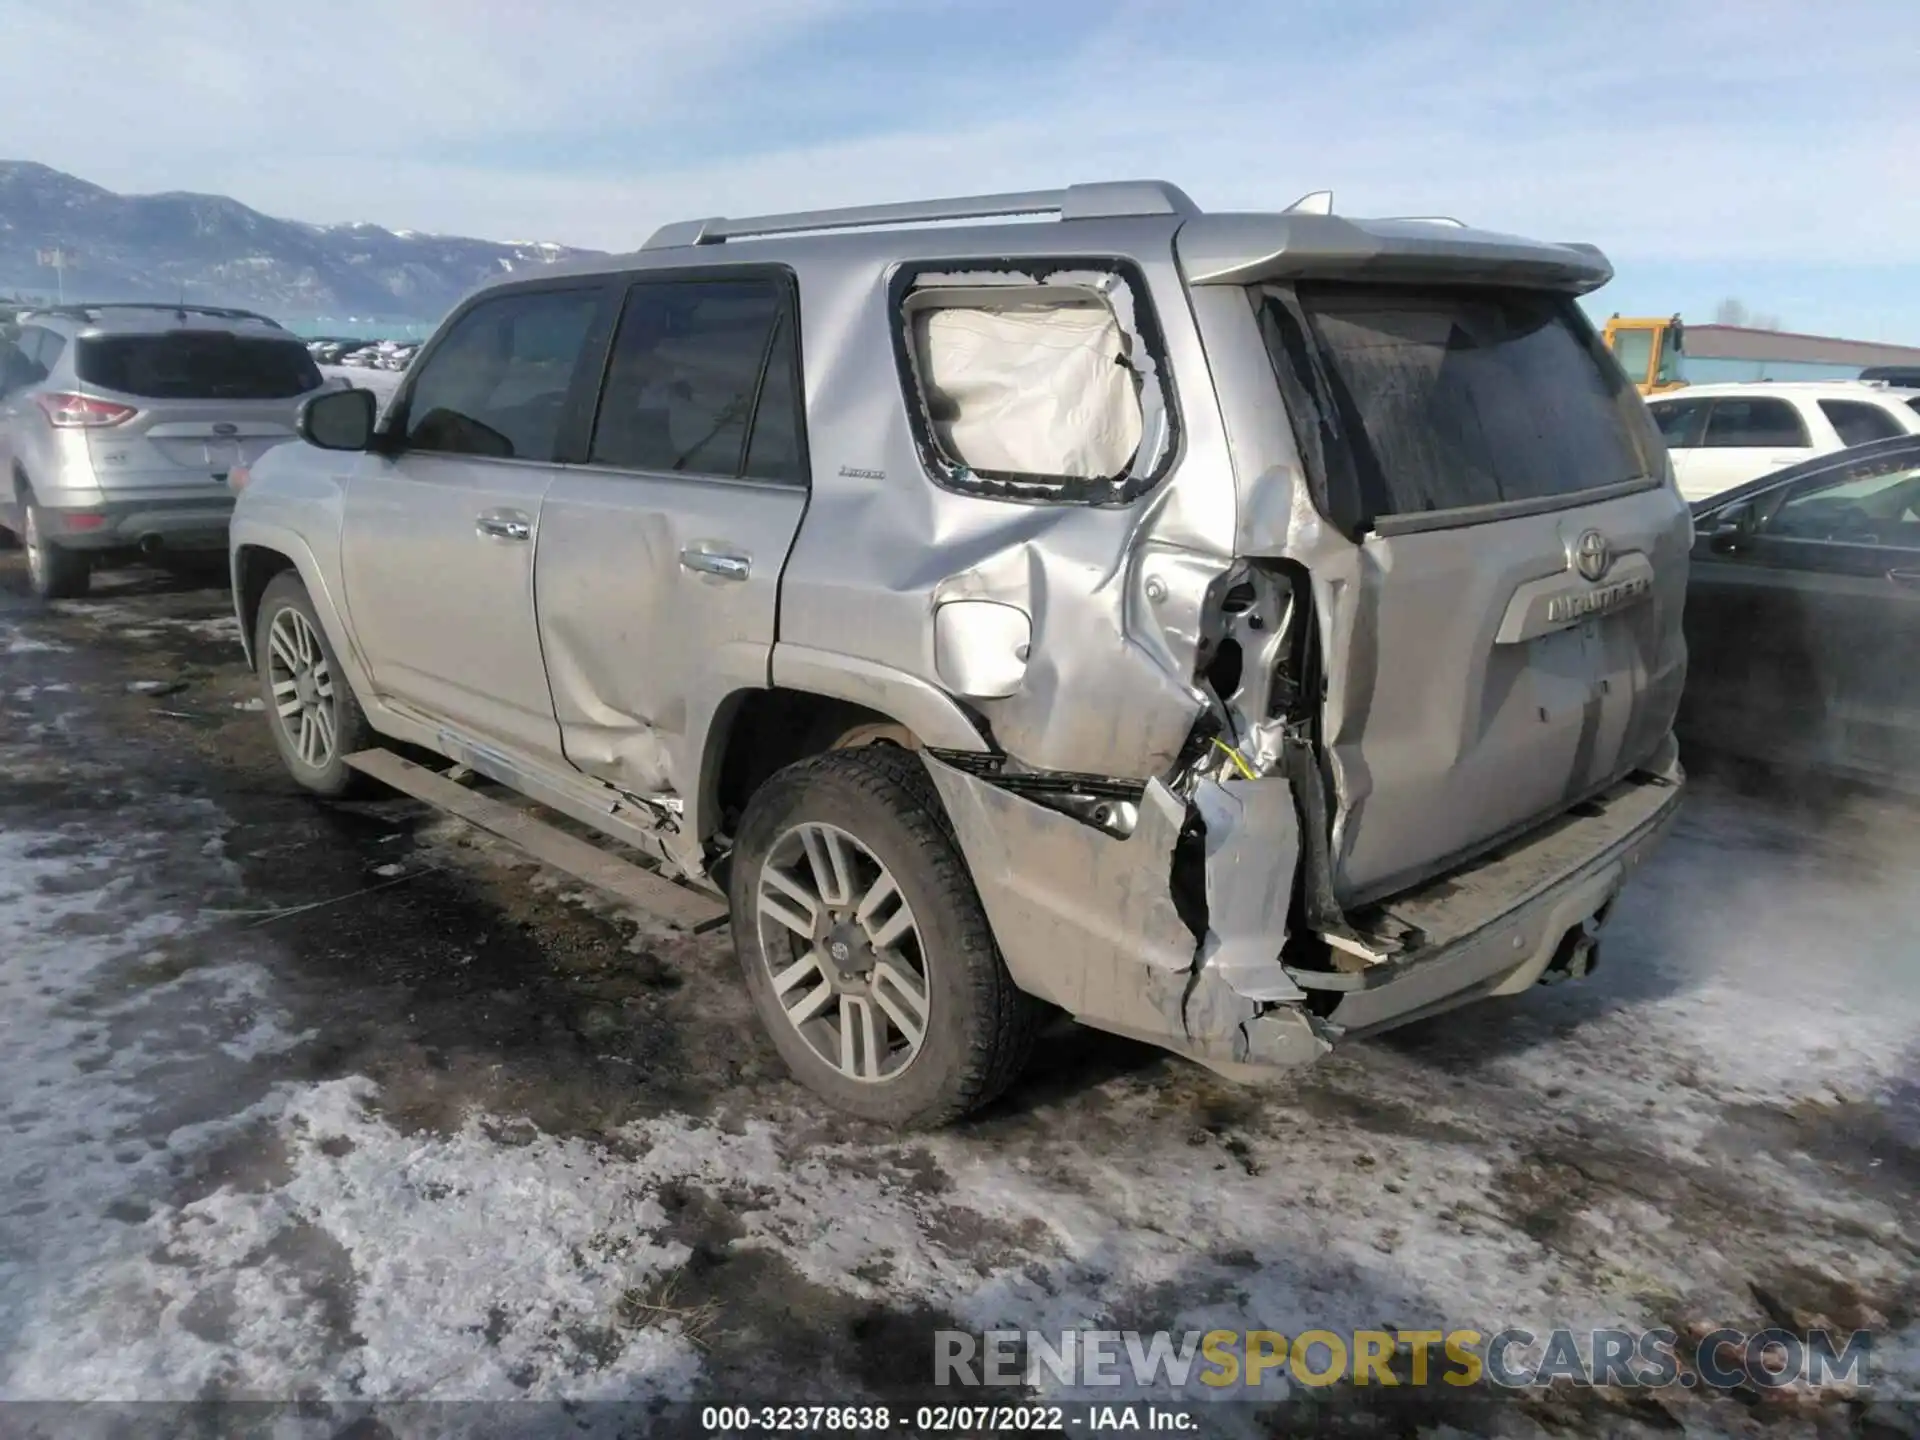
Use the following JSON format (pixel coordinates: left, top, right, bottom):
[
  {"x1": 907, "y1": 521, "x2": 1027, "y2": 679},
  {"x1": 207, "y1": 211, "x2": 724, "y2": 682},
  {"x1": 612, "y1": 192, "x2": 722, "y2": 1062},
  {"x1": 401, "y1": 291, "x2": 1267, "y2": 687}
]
[{"x1": 253, "y1": 570, "x2": 374, "y2": 799}]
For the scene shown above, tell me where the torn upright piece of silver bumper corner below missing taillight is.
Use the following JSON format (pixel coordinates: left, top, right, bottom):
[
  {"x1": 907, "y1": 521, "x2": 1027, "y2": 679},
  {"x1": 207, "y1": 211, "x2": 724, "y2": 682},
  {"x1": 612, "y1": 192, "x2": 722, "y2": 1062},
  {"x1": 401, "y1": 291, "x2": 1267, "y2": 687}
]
[{"x1": 1194, "y1": 780, "x2": 1306, "y2": 1002}]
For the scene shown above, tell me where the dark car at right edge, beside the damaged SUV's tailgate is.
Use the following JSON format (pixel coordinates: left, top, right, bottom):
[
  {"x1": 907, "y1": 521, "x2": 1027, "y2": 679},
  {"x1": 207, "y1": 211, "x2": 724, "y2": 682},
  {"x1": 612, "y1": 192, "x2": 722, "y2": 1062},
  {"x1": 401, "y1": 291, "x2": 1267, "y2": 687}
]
[{"x1": 1680, "y1": 436, "x2": 1920, "y2": 785}]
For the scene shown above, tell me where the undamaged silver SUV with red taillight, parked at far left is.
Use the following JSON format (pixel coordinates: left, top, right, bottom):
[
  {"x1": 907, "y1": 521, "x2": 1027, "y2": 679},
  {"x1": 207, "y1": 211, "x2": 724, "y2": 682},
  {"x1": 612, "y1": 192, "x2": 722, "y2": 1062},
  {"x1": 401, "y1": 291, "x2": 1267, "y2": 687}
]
[{"x1": 0, "y1": 303, "x2": 324, "y2": 599}]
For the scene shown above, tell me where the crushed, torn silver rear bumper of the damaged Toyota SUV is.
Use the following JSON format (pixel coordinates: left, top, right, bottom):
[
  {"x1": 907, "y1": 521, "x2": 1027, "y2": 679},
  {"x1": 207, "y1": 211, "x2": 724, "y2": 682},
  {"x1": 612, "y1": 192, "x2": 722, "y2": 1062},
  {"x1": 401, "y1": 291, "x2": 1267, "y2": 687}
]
[{"x1": 925, "y1": 737, "x2": 1684, "y2": 1073}]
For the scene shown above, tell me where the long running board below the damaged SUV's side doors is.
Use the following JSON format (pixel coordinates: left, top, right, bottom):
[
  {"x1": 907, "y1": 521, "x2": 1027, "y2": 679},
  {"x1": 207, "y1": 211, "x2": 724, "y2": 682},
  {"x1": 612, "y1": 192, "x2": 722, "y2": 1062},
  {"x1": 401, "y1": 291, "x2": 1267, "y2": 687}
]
[{"x1": 348, "y1": 749, "x2": 728, "y2": 931}]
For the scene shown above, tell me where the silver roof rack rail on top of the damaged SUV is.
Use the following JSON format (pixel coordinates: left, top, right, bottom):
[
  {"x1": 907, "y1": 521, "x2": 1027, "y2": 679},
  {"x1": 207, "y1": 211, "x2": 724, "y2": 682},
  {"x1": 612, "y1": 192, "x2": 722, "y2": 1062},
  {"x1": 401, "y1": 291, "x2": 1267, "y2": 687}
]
[{"x1": 641, "y1": 180, "x2": 1200, "y2": 250}]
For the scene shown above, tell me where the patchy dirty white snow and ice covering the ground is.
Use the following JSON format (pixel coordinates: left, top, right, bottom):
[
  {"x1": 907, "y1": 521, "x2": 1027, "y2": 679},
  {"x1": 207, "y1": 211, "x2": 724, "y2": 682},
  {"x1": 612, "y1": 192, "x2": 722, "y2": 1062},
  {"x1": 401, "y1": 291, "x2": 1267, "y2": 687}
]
[{"x1": 0, "y1": 599, "x2": 1920, "y2": 1436}]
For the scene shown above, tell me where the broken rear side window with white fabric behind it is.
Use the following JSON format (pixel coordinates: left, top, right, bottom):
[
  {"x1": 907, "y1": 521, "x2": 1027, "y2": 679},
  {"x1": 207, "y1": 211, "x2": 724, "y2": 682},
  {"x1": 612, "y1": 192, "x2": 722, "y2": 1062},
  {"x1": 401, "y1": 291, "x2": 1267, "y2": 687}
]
[{"x1": 893, "y1": 261, "x2": 1175, "y2": 505}]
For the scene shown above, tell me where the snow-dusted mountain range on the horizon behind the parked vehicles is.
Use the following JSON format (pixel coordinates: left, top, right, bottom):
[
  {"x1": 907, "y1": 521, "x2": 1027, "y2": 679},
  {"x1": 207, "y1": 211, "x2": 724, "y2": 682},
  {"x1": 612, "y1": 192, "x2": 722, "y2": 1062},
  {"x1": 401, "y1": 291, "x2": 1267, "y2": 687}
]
[{"x1": 0, "y1": 161, "x2": 595, "y2": 321}]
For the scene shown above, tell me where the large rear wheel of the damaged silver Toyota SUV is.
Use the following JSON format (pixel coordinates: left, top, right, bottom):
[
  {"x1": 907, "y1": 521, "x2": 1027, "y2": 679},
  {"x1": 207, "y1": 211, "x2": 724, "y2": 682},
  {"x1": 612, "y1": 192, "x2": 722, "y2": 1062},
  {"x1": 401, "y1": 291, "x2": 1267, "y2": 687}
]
[{"x1": 730, "y1": 745, "x2": 1039, "y2": 1129}]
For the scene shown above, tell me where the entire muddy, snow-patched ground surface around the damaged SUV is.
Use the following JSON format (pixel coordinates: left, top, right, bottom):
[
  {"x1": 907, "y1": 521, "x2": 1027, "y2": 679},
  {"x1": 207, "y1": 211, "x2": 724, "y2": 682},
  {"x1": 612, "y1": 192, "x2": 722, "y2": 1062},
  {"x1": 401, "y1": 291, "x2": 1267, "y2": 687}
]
[{"x1": 0, "y1": 551, "x2": 1920, "y2": 1434}]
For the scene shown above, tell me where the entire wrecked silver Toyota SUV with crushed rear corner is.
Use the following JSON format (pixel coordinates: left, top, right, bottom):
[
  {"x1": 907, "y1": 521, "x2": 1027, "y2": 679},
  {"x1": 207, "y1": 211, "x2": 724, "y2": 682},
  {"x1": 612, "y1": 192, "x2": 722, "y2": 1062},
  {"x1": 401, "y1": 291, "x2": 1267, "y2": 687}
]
[{"x1": 232, "y1": 182, "x2": 1692, "y2": 1123}]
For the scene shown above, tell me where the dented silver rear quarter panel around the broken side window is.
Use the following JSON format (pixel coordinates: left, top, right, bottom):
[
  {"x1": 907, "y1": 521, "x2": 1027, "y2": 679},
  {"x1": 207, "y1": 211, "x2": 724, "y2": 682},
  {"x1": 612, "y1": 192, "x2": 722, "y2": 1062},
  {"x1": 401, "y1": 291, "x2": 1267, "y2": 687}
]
[{"x1": 780, "y1": 217, "x2": 1236, "y2": 780}]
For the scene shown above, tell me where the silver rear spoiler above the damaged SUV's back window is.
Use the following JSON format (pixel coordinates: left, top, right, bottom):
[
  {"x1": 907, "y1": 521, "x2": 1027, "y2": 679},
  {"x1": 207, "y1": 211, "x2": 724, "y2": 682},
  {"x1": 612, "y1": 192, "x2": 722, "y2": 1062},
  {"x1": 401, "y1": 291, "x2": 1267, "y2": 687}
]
[{"x1": 1173, "y1": 213, "x2": 1613, "y2": 296}]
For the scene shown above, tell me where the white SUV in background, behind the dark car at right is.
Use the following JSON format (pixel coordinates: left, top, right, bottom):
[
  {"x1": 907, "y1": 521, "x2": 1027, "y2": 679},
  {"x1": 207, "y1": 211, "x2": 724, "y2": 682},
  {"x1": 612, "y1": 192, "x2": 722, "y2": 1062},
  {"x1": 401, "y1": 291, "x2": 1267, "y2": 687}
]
[{"x1": 1647, "y1": 380, "x2": 1920, "y2": 501}]
